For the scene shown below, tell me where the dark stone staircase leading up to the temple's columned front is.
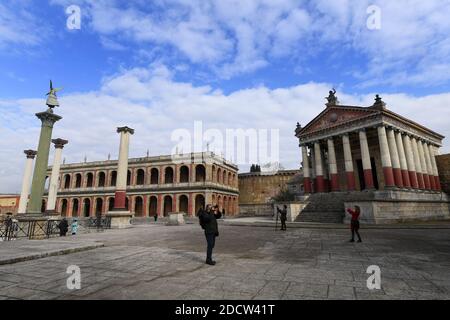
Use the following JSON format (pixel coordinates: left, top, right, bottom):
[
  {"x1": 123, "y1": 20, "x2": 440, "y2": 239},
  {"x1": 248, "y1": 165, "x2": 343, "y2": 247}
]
[{"x1": 295, "y1": 192, "x2": 346, "y2": 223}]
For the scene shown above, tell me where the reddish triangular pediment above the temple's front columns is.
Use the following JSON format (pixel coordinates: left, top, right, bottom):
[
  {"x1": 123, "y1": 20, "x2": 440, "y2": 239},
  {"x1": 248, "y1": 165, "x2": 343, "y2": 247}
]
[{"x1": 297, "y1": 106, "x2": 380, "y2": 136}]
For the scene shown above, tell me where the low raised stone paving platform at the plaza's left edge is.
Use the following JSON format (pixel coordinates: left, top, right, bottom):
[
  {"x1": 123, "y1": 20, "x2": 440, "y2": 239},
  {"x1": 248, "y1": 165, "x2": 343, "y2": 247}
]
[{"x1": 0, "y1": 239, "x2": 103, "y2": 265}]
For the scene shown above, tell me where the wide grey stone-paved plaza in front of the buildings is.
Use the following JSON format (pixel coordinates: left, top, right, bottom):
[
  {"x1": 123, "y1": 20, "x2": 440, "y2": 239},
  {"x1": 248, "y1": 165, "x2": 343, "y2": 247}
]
[{"x1": 0, "y1": 223, "x2": 450, "y2": 300}]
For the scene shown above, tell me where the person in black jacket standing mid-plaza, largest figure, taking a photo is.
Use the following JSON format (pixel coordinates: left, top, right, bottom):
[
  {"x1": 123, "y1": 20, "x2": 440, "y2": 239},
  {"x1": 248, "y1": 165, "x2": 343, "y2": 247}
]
[{"x1": 199, "y1": 205, "x2": 222, "y2": 266}]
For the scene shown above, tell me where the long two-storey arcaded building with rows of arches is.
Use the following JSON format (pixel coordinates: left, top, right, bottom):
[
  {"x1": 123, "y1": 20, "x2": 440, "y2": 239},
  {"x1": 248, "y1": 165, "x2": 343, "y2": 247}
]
[{"x1": 43, "y1": 152, "x2": 239, "y2": 217}]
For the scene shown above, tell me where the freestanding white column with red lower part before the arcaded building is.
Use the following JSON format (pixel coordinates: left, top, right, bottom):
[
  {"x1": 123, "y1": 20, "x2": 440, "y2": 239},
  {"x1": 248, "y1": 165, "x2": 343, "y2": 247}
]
[{"x1": 114, "y1": 127, "x2": 134, "y2": 211}]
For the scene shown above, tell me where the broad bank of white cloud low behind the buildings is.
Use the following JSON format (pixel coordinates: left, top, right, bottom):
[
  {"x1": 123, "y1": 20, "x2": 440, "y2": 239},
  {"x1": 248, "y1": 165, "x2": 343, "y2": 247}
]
[{"x1": 0, "y1": 64, "x2": 450, "y2": 192}]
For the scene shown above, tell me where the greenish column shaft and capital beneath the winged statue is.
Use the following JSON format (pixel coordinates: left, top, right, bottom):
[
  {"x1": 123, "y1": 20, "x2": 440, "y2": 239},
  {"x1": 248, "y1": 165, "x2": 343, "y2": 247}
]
[{"x1": 27, "y1": 108, "x2": 62, "y2": 214}]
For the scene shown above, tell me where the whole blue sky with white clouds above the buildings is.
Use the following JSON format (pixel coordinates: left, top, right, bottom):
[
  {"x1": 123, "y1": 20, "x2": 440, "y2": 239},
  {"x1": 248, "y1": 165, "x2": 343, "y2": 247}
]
[{"x1": 0, "y1": 0, "x2": 450, "y2": 193}]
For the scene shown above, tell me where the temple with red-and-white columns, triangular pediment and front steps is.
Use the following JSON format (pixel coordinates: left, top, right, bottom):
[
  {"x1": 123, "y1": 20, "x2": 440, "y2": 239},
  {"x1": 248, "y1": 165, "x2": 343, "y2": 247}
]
[{"x1": 295, "y1": 91, "x2": 449, "y2": 223}]
